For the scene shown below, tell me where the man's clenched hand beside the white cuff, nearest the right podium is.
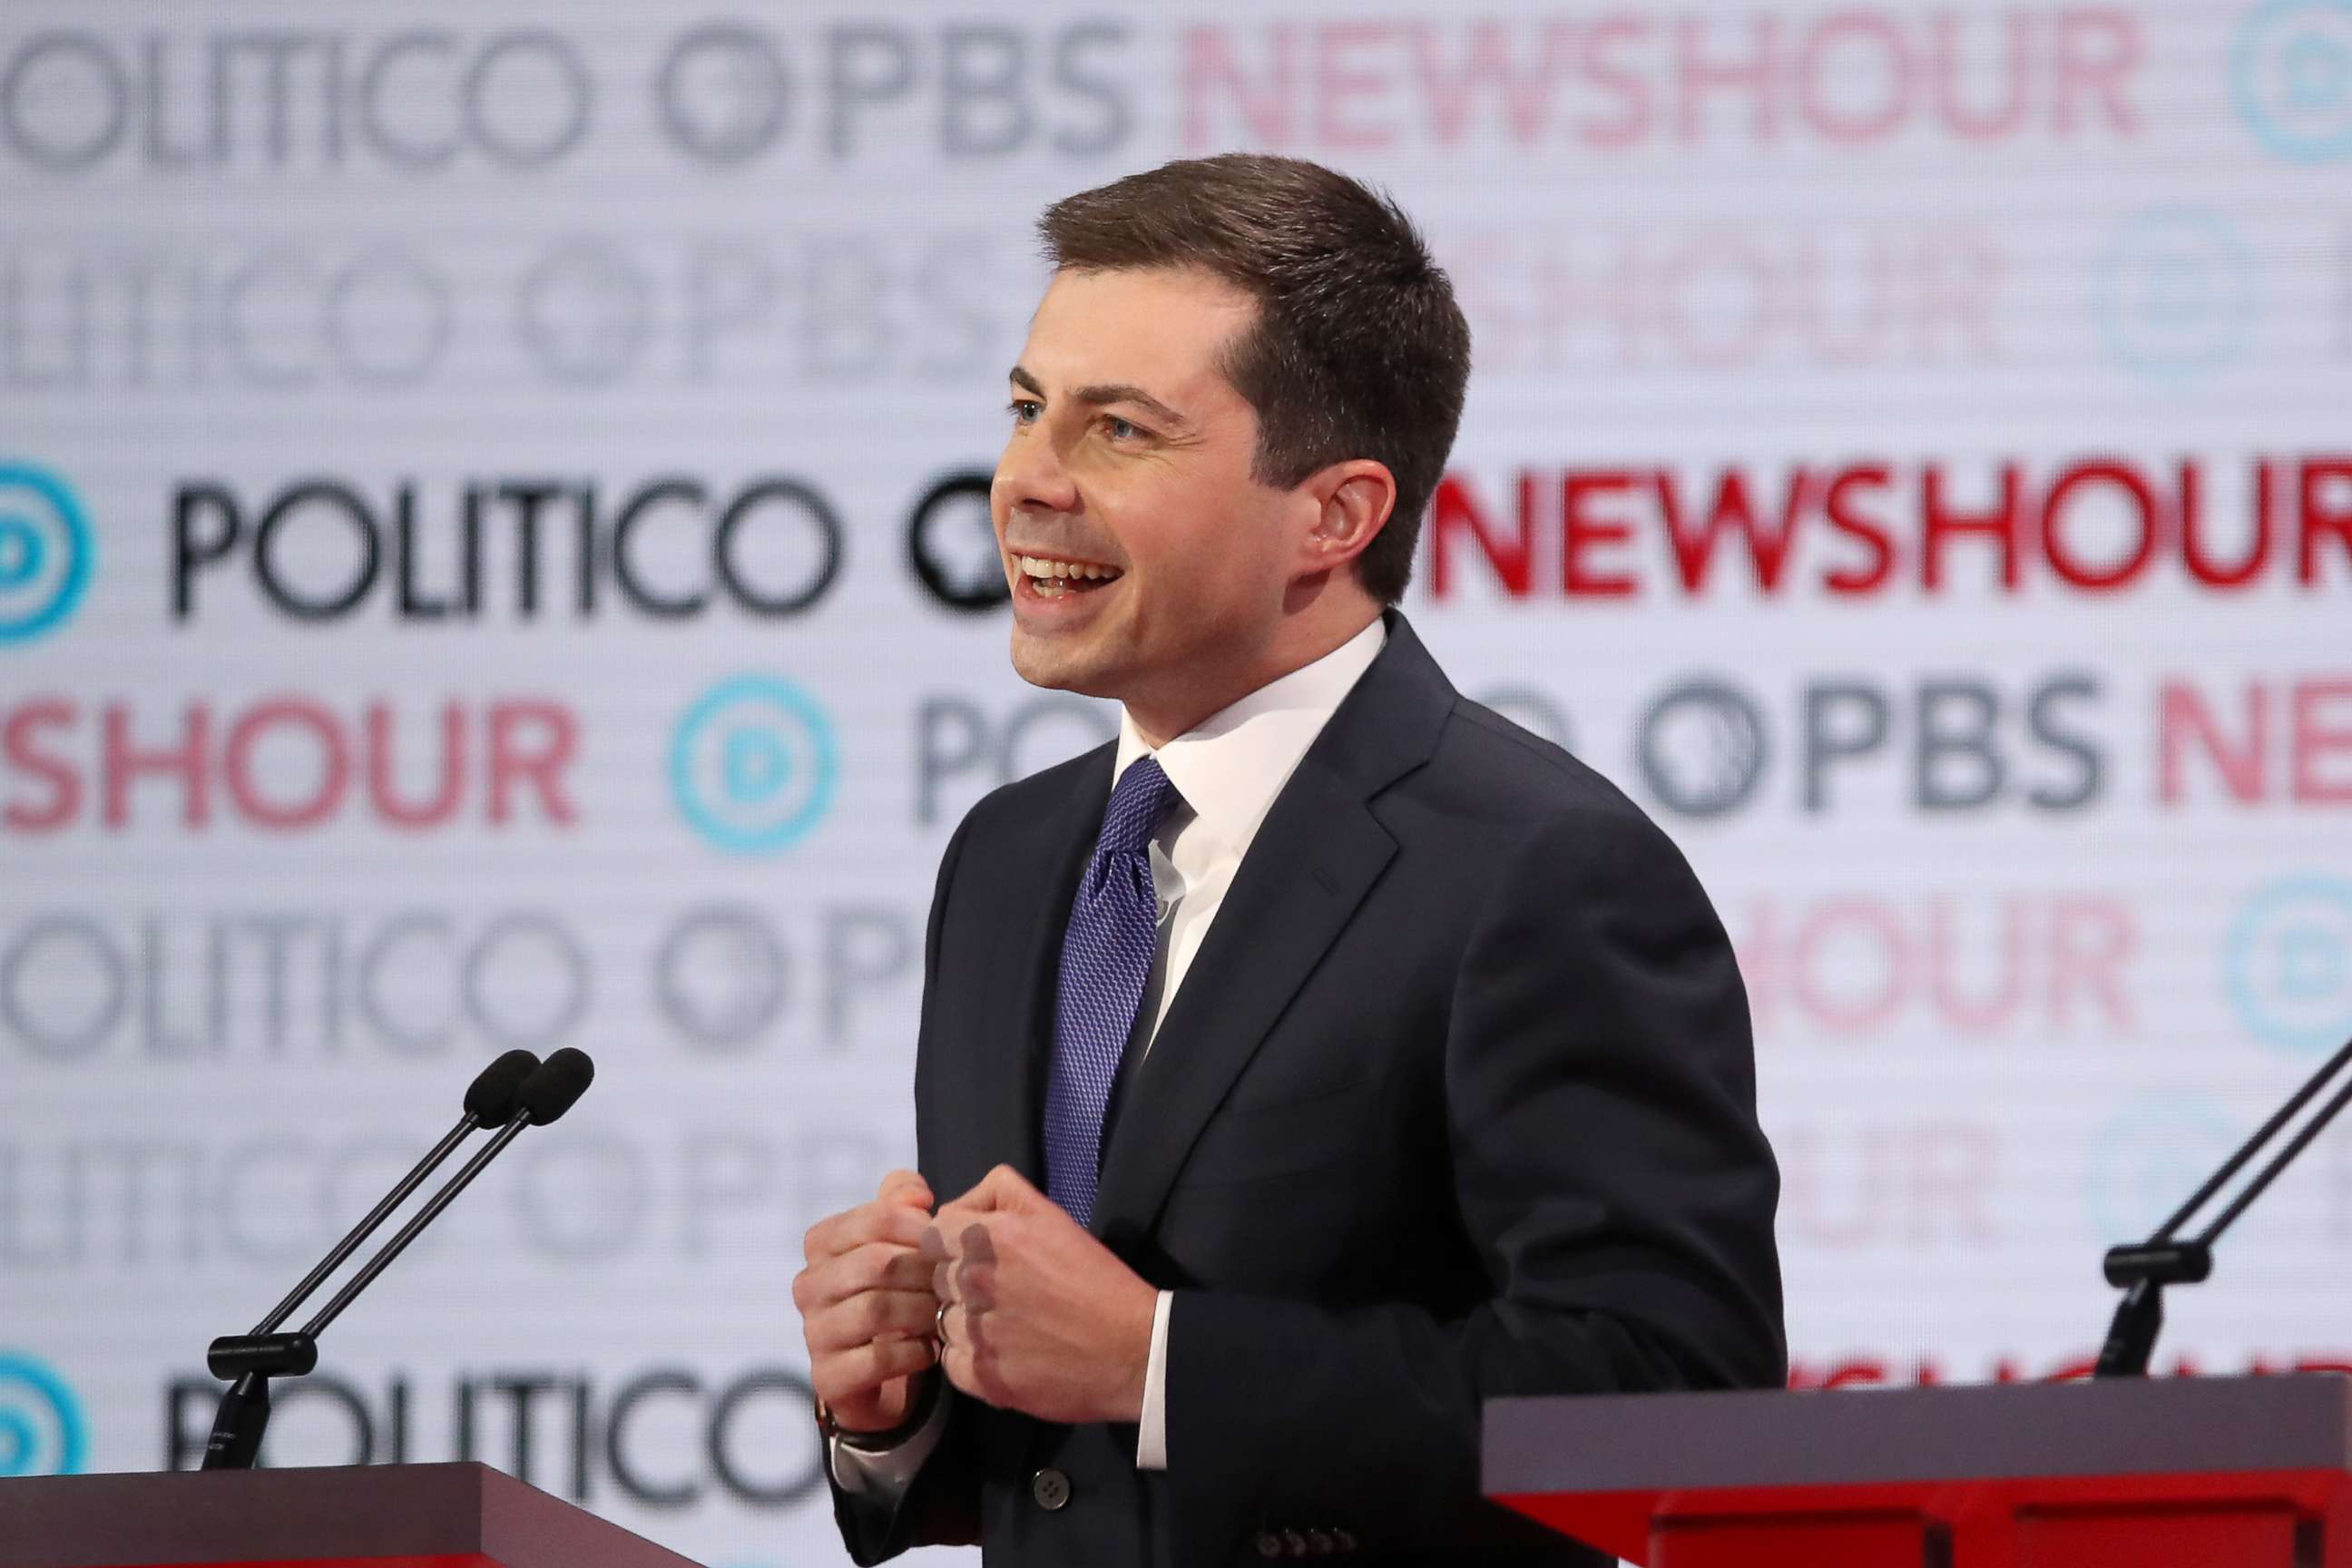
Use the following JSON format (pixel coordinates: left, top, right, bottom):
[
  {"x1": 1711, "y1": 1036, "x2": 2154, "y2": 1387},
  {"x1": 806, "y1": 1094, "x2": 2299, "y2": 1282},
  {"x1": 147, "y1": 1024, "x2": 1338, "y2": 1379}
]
[{"x1": 922, "y1": 1166, "x2": 1160, "y2": 1422}]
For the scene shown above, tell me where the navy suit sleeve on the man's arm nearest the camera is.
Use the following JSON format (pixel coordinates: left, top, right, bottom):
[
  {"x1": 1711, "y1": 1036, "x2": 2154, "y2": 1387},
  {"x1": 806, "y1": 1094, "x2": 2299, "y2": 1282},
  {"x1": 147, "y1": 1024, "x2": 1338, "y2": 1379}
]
[{"x1": 1167, "y1": 801, "x2": 1788, "y2": 1561}]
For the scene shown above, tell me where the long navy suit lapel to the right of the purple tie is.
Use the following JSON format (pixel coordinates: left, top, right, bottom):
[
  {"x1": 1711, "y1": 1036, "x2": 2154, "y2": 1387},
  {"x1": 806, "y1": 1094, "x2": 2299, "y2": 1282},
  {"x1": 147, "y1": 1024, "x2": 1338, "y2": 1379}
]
[{"x1": 1086, "y1": 612, "x2": 1454, "y2": 1246}]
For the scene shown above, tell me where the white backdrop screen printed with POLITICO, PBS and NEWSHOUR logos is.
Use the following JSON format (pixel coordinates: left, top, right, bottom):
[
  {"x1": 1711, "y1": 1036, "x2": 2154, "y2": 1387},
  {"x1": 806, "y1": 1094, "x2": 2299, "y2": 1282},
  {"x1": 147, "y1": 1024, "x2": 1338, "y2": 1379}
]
[{"x1": 0, "y1": 0, "x2": 2352, "y2": 1568}]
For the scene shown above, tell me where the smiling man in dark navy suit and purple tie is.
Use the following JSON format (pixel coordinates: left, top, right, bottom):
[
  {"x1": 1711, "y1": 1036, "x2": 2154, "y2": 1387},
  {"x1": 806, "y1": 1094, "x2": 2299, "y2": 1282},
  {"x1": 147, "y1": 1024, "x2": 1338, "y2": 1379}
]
[{"x1": 795, "y1": 155, "x2": 1785, "y2": 1568}]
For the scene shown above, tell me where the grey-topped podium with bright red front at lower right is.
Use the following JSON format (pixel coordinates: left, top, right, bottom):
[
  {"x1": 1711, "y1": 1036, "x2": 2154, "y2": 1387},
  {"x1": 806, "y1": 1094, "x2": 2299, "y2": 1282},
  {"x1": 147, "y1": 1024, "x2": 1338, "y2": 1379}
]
[{"x1": 1485, "y1": 1373, "x2": 2352, "y2": 1568}]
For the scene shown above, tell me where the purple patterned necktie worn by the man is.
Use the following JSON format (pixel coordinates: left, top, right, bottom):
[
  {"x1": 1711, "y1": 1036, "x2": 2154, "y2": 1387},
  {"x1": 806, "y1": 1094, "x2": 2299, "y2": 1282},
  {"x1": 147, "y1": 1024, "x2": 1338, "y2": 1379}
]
[{"x1": 1044, "y1": 757, "x2": 1179, "y2": 1225}]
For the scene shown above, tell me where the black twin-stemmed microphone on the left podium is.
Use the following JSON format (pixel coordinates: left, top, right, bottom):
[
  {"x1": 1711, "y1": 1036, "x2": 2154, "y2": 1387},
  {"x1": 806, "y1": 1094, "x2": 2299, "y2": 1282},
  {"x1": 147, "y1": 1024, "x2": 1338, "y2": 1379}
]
[{"x1": 202, "y1": 1046, "x2": 595, "y2": 1469}]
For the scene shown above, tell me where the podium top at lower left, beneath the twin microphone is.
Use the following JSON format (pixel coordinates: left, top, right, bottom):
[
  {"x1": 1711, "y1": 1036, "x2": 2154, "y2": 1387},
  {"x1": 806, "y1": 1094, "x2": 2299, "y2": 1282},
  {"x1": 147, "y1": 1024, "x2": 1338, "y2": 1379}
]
[{"x1": 0, "y1": 1465, "x2": 696, "y2": 1568}]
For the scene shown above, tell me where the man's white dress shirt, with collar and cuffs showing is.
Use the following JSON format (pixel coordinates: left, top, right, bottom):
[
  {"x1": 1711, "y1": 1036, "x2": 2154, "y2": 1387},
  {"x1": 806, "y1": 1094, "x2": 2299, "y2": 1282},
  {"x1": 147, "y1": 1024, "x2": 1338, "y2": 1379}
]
[{"x1": 833, "y1": 621, "x2": 1387, "y2": 1497}]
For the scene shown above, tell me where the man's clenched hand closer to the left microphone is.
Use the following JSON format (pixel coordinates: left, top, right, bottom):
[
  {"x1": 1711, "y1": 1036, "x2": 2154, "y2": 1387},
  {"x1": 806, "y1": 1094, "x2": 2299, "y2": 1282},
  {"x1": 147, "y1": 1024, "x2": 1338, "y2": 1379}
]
[{"x1": 793, "y1": 1171, "x2": 938, "y2": 1432}]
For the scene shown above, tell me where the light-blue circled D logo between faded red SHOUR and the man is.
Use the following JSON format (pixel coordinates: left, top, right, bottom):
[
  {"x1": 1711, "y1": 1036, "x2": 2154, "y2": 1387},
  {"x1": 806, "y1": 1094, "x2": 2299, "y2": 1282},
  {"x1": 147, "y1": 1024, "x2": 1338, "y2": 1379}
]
[{"x1": 671, "y1": 675, "x2": 839, "y2": 856}]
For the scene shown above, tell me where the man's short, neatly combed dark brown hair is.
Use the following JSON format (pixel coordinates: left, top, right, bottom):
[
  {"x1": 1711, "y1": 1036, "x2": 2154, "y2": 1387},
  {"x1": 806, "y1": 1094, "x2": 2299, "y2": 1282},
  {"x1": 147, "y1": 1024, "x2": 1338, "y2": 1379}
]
[{"x1": 1037, "y1": 152, "x2": 1470, "y2": 604}]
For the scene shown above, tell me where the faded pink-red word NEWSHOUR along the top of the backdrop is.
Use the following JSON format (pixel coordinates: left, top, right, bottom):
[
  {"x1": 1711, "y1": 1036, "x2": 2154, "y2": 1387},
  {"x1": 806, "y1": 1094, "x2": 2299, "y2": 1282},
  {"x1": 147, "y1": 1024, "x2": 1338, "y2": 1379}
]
[{"x1": 1179, "y1": 7, "x2": 2147, "y2": 152}]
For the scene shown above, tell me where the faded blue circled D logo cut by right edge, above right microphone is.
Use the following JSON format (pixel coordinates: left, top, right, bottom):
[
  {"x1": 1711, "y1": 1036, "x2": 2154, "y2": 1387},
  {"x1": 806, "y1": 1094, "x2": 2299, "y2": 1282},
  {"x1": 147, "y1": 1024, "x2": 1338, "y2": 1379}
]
[{"x1": 2222, "y1": 877, "x2": 2352, "y2": 1051}]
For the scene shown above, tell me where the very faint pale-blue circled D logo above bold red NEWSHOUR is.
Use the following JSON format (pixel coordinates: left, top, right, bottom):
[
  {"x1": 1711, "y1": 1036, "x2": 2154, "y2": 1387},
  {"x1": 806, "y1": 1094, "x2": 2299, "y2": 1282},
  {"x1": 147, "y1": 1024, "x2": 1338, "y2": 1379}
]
[{"x1": 2098, "y1": 207, "x2": 2253, "y2": 377}]
